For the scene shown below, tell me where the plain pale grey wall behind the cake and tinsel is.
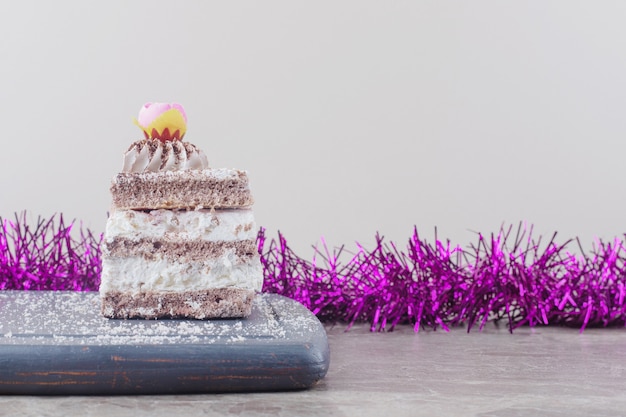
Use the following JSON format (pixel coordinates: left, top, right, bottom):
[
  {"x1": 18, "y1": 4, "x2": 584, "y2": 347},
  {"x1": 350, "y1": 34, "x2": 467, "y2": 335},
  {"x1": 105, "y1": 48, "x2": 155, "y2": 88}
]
[{"x1": 0, "y1": 0, "x2": 626, "y2": 257}]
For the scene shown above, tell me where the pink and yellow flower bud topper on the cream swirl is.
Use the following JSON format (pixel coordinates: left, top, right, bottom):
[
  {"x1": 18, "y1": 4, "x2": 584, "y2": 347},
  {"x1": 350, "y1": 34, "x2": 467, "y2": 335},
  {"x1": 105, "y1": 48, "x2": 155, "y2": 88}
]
[{"x1": 135, "y1": 103, "x2": 187, "y2": 142}]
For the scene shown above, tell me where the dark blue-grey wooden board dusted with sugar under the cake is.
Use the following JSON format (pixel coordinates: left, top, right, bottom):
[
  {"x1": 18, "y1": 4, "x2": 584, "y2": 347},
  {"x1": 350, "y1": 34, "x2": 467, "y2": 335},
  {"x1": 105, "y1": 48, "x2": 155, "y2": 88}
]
[{"x1": 0, "y1": 291, "x2": 330, "y2": 395}]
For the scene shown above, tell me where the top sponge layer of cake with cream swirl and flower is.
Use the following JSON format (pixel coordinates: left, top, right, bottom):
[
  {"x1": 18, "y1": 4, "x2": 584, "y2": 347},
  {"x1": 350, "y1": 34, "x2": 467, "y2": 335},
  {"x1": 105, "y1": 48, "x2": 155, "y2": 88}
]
[{"x1": 111, "y1": 103, "x2": 254, "y2": 210}]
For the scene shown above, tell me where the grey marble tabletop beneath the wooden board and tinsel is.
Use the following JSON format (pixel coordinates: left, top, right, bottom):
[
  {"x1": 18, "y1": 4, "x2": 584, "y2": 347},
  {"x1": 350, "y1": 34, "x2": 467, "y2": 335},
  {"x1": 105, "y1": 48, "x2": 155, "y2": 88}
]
[{"x1": 0, "y1": 325, "x2": 626, "y2": 417}]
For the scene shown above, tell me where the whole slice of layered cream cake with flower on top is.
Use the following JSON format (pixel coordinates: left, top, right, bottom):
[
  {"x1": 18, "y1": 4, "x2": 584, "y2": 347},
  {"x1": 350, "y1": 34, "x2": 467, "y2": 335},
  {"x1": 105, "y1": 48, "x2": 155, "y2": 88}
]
[{"x1": 100, "y1": 103, "x2": 263, "y2": 319}]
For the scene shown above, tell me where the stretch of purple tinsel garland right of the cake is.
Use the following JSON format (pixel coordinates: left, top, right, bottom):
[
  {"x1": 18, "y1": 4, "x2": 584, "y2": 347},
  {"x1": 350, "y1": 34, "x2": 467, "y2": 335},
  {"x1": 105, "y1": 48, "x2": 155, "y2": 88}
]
[{"x1": 258, "y1": 225, "x2": 626, "y2": 331}]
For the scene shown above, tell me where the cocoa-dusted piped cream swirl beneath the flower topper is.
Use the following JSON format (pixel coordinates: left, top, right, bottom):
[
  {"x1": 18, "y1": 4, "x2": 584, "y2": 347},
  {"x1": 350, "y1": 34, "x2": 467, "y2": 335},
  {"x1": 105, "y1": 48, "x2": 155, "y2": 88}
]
[{"x1": 122, "y1": 139, "x2": 209, "y2": 172}]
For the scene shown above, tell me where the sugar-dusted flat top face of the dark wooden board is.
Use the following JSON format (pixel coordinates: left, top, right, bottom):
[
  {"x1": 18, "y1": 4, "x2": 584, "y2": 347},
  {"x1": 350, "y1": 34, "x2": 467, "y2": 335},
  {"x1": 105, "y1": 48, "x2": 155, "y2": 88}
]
[{"x1": 0, "y1": 291, "x2": 321, "y2": 346}]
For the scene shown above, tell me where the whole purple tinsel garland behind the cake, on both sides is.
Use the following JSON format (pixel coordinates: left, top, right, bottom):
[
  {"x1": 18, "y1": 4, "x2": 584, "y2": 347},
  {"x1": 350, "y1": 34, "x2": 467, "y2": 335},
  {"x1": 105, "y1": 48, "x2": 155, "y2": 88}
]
[{"x1": 0, "y1": 213, "x2": 626, "y2": 331}]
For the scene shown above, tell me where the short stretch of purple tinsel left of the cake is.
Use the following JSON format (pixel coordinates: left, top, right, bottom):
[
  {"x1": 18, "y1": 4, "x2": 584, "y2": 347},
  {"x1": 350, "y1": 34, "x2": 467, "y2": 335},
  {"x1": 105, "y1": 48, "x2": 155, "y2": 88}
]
[{"x1": 0, "y1": 212, "x2": 102, "y2": 291}]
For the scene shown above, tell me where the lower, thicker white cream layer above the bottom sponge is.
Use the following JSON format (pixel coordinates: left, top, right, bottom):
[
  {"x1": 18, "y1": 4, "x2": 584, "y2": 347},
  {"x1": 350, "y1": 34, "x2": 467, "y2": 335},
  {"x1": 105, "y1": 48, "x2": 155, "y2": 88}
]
[{"x1": 100, "y1": 253, "x2": 263, "y2": 293}]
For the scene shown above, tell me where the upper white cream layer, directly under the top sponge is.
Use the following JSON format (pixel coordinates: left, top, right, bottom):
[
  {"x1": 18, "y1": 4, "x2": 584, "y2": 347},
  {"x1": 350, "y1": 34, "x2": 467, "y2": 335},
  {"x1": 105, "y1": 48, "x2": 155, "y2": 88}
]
[{"x1": 105, "y1": 209, "x2": 258, "y2": 242}]
